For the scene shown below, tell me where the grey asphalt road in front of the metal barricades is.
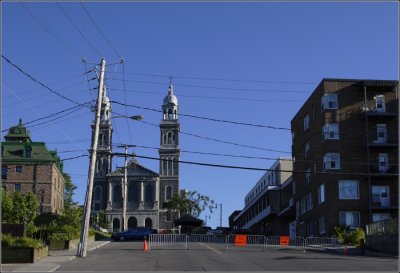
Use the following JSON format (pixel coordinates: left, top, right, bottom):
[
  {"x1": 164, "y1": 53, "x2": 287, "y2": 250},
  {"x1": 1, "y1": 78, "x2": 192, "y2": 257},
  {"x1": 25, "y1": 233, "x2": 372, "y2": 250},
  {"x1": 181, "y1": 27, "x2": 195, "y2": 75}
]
[{"x1": 57, "y1": 242, "x2": 398, "y2": 272}]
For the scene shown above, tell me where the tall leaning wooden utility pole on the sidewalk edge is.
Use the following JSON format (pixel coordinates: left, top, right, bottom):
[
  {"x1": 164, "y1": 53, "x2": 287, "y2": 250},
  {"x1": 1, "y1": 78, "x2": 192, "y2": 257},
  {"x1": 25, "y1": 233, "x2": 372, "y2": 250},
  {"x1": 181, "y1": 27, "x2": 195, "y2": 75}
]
[{"x1": 76, "y1": 59, "x2": 106, "y2": 257}]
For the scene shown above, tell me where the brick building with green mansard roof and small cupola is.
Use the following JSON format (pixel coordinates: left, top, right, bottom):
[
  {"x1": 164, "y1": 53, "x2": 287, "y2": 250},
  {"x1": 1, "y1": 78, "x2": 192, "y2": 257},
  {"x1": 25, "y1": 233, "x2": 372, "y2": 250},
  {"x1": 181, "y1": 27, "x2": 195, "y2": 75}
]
[{"x1": 1, "y1": 119, "x2": 64, "y2": 213}]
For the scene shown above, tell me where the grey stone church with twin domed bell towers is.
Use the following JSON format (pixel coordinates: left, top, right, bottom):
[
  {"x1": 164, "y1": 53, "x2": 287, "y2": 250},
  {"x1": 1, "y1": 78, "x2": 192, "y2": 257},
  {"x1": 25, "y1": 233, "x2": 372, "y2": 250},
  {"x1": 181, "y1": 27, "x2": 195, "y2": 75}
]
[{"x1": 91, "y1": 83, "x2": 180, "y2": 232}]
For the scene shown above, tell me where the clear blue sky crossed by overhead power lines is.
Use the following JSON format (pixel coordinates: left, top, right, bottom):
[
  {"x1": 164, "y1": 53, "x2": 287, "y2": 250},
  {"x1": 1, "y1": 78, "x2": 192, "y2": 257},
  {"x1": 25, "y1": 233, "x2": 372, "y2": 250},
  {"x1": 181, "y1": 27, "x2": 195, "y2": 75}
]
[{"x1": 1, "y1": 2, "x2": 399, "y2": 227}]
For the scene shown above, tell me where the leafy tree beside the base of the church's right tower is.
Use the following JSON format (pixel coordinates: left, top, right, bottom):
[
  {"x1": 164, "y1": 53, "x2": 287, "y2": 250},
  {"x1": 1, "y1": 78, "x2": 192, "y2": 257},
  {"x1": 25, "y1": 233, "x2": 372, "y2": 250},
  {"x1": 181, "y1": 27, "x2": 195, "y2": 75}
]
[{"x1": 164, "y1": 191, "x2": 215, "y2": 217}]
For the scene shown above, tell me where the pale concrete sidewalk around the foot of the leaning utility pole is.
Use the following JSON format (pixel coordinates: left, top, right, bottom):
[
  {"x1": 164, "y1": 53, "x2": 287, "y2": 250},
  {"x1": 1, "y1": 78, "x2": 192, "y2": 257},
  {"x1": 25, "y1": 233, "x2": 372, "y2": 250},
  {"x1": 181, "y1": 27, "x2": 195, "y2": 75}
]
[{"x1": 1, "y1": 241, "x2": 110, "y2": 272}]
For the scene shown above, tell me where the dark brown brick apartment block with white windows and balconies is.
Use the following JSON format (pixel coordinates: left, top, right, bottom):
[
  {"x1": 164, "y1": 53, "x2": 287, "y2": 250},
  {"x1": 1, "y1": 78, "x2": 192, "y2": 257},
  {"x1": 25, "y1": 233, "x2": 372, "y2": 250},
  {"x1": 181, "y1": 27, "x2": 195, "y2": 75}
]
[{"x1": 291, "y1": 79, "x2": 399, "y2": 236}]
